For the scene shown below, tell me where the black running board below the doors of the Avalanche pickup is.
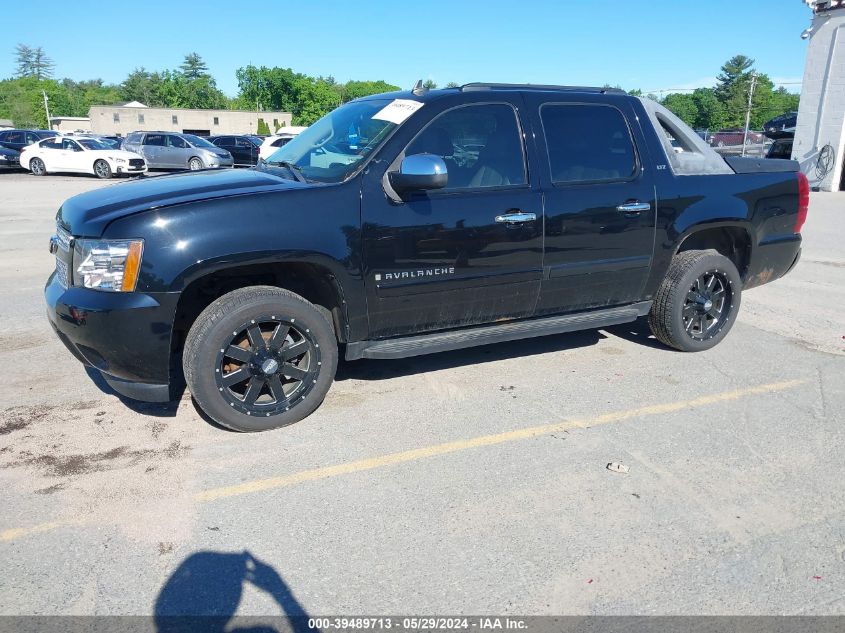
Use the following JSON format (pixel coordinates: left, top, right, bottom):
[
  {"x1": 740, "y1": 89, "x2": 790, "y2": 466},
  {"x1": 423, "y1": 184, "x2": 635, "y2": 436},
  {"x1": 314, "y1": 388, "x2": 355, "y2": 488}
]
[{"x1": 346, "y1": 301, "x2": 651, "y2": 360}]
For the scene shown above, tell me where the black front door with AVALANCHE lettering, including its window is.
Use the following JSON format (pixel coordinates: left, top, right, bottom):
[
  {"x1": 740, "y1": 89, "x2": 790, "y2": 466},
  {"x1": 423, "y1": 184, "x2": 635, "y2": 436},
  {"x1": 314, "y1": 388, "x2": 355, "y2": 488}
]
[{"x1": 362, "y1": 101, "x2": 543, "y2": 338}]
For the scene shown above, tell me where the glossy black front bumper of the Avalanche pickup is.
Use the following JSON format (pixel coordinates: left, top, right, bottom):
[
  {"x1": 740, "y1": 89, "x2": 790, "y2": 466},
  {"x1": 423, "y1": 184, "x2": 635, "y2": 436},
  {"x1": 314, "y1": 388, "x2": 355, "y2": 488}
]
[{"x1": 44, "y1": 273, "x2": 179, "y2": 402}]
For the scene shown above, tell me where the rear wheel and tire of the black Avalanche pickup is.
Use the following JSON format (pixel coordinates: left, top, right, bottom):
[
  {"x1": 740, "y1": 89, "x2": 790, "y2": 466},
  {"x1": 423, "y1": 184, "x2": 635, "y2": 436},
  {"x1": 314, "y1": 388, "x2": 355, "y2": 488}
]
[{"x1": 648, "y1": 250, "x2": 742, "y2": 352}]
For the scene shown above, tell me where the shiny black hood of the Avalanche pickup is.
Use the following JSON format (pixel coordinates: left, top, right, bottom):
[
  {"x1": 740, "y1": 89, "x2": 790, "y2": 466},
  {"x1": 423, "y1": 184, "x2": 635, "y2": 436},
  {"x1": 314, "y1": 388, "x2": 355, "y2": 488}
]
[{"x1": 57, "y1": 169, "x2": 315, "y2": 237}]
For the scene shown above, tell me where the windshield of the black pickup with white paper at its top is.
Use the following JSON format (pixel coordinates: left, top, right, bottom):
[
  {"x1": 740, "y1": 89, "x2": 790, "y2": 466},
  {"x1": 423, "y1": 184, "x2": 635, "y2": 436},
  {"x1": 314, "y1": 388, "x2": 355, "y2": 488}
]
[{"x1": 267, "y1": 99, "x2": 406, "y2": 182}]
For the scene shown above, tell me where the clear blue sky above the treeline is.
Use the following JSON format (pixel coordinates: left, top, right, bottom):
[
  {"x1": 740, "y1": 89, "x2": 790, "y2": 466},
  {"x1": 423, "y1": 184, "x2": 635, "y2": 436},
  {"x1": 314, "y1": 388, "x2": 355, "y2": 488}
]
[{"x1": 0, "y1": 0, "x2": 810, "y2": 96}]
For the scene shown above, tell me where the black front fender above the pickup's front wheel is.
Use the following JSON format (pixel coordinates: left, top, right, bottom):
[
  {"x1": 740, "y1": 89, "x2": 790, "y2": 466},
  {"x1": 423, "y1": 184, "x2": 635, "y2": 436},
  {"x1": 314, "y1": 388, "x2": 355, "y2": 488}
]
[{"x1": 103, "y1": 183, "x2": 366, "y2": 336}]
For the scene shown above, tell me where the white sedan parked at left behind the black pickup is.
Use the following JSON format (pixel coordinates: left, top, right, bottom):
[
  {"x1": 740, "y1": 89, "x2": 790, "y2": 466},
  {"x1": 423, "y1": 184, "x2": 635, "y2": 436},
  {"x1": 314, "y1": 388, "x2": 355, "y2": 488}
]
[{"x1": 20, "y1": 136, "x2": 147, "y2": 178}]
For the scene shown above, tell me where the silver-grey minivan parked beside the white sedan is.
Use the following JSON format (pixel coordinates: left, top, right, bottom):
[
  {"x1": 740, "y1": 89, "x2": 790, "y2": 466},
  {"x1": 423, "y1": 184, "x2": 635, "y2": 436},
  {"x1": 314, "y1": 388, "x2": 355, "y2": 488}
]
[{"x1": 123, "y1": 132, "x2": 234, "y2": 170}]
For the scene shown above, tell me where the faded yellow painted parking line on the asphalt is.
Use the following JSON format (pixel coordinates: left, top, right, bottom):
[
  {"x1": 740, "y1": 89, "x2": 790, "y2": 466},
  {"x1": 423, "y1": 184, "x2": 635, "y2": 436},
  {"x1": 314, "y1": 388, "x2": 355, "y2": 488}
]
[{"x1": 0, "y1": 380, "x2": 807, "y2": 542}]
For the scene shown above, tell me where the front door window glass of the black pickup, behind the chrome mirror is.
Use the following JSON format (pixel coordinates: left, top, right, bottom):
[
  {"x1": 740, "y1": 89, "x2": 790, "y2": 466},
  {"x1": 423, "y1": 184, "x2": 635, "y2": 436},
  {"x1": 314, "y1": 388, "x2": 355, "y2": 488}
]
[{"x1": 405, "y1": 104, "x2": 526, "y2": 189}]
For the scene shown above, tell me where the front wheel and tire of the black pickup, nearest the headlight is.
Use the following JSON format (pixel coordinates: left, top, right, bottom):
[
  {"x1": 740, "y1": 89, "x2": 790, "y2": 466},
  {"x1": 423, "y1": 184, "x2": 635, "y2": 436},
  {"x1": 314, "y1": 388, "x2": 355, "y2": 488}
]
[{"x1": 182, "y1": 286, "x2": 338, "y2": 432}]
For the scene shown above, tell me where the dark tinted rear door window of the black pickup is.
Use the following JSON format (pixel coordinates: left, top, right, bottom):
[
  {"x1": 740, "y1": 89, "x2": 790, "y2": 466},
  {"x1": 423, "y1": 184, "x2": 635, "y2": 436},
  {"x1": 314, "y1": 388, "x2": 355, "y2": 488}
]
[{"x1": 540, "y1": 104, "x2": 637, "y2": 183}]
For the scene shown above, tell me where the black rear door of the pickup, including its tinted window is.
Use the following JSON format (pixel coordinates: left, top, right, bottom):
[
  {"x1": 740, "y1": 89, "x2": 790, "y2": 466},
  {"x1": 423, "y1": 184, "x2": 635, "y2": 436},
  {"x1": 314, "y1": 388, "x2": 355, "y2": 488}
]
[{"x1": 526, "y1": 94, "x2": 656, "y2": 315}]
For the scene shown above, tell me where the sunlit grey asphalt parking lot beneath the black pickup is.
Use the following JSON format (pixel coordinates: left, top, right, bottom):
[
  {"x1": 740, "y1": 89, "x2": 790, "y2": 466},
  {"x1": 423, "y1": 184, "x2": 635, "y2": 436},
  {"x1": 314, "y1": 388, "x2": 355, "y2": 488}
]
[{"x1": 0, "y1": 173, "x2": 845, "y2": 615}]
